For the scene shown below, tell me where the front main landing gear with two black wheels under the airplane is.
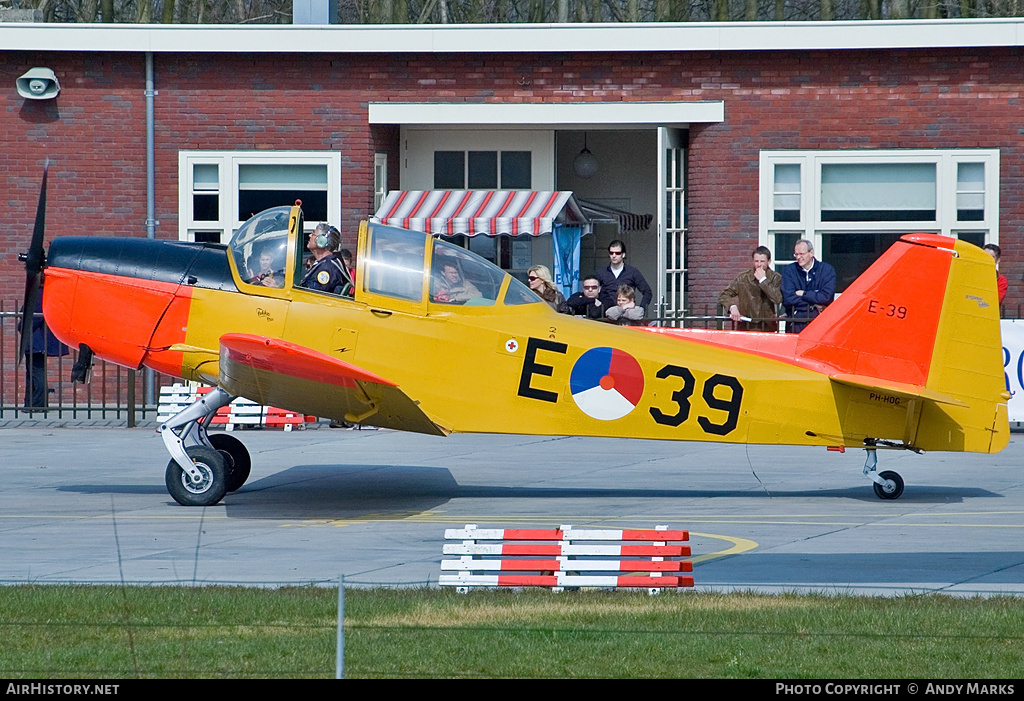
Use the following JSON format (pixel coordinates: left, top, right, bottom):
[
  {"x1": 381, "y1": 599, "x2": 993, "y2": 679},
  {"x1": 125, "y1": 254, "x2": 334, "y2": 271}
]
[{"x1": 160, "y1": 387, "x2": 252, "y2": 507}]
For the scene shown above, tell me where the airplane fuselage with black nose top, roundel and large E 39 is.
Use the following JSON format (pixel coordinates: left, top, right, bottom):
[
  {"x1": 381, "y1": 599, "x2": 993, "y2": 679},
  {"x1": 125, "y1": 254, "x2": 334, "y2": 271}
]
[{"x1": 44, "y1": 239, "x2": 966, "y2": 448}]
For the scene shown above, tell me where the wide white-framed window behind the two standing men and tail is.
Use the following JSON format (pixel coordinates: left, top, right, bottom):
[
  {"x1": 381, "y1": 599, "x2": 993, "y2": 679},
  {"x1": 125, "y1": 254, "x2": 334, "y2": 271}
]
[{"x1": 760, "y1": 148, "x2": 999, "y2": 292}]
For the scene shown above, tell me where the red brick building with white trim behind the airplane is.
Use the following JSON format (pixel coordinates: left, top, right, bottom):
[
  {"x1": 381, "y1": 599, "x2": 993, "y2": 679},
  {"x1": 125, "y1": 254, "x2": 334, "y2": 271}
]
[{"x1": 0, "y1": 19, "x2": 1024, "y2": 315}]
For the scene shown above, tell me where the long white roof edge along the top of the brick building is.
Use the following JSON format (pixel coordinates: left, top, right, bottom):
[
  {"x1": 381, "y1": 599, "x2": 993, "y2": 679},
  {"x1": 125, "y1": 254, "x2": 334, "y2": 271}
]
[{"x1": 0, "y1": 17, "x2": 1024, "y2": 53}]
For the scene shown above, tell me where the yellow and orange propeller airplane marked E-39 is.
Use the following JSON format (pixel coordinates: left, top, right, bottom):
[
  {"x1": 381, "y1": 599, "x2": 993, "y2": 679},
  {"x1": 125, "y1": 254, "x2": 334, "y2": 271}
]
[{"x1": 26, "y1": 176, "x2": 1010, "y2": 506}]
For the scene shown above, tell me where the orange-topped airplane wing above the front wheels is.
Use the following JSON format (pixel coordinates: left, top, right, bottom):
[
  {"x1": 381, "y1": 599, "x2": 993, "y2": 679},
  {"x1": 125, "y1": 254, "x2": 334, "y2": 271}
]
[{"x1": 220, "y1": 334, "x2": 451, "y2": 436}]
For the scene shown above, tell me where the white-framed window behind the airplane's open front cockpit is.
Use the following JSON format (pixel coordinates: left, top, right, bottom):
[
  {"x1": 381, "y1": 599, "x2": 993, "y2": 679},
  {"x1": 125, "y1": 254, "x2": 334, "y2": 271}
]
[{"x1": 178, "y1": 151, "x2": 341, "y2": 244}]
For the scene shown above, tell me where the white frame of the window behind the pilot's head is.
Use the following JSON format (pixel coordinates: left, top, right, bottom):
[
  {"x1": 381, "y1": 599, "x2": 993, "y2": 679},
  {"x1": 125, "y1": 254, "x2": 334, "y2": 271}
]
[{"x1": 178, "y1": 150, "x2": 341, "y2": 244}]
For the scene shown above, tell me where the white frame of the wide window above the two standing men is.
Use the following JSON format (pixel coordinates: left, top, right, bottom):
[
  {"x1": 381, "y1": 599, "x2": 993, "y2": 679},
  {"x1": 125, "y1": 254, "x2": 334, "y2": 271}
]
[{"x1": 758, "y1": 148, "x2": 999, "y2": 260}]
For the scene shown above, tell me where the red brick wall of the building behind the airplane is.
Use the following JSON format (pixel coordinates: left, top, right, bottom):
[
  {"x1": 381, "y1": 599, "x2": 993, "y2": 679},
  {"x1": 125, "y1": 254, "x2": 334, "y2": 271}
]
[{"x1": 6, "y1": 49, "x2": 1024, "y2": 308}]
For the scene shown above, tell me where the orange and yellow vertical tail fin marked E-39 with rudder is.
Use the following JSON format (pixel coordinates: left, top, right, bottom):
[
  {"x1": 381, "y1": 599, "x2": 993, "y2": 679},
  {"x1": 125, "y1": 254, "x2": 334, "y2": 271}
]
[{"x1": 797, "y1": 233, "x2": 1009, "y2": 452}]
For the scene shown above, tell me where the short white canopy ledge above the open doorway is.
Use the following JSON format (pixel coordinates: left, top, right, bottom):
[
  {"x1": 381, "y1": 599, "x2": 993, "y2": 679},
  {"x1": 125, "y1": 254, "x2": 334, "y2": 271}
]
[{"x1": 370, "y1": 100, "x2": 725, "y2": 128}]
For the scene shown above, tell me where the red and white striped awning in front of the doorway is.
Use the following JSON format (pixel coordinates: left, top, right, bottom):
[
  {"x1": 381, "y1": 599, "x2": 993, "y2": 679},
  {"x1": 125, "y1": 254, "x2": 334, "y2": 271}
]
[{"x1": 372, "y1": 190, "x2": 591, "y2": 236}]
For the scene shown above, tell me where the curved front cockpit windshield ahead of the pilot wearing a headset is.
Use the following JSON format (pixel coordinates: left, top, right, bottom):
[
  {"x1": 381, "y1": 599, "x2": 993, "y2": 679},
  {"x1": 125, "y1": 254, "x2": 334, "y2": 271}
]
[{"x1": 229, "y1": 207, "x2": 292, "y2": 288}]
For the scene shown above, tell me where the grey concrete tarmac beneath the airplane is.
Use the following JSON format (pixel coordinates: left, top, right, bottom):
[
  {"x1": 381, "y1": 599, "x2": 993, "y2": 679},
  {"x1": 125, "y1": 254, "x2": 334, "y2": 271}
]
[{"x1": 0, "y1": 422, "x2": 1024, "y2": 596}]
